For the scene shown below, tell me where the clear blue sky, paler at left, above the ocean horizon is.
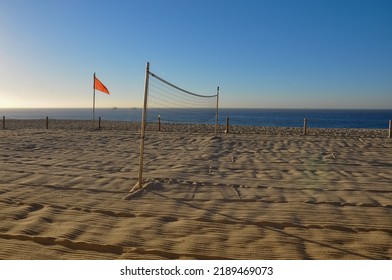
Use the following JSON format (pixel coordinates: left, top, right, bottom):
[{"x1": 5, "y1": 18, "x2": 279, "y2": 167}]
[{"x1": 0, "y1": 0, "x2": 392, "y2": 109}]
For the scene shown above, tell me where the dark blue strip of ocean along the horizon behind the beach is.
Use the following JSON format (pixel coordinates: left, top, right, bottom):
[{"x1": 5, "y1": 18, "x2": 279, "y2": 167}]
[{"x1": 0, "y1": 108, "x2": 392, "y2": 129}]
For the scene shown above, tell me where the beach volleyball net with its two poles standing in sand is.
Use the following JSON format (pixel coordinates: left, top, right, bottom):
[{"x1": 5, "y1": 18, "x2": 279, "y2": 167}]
[{"x1": 131, "y1": 62, "x2": 219, "y2": 193}]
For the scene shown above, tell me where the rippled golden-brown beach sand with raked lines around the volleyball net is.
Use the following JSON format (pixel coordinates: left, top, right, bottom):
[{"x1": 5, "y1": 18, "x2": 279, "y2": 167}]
[{"x1": 0, "y1": 122, "x2": 392, "y2": 260}]
